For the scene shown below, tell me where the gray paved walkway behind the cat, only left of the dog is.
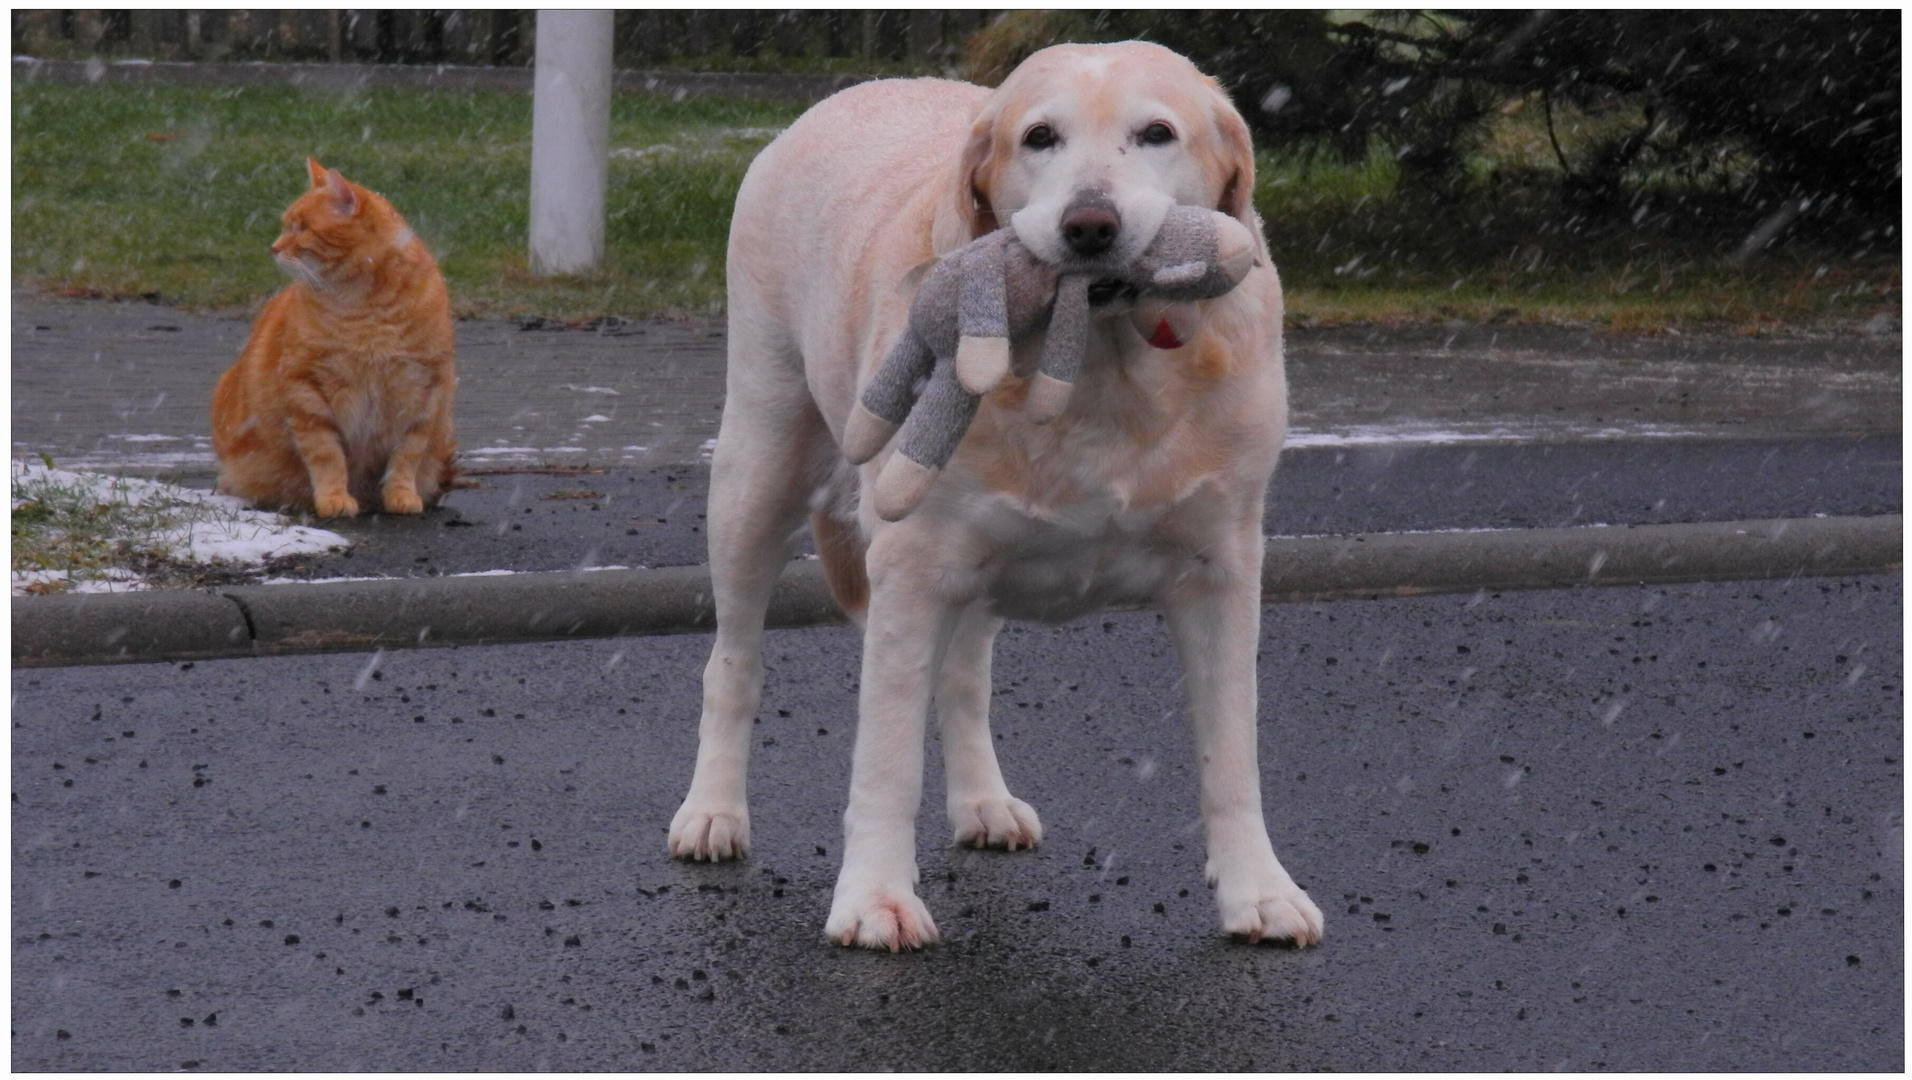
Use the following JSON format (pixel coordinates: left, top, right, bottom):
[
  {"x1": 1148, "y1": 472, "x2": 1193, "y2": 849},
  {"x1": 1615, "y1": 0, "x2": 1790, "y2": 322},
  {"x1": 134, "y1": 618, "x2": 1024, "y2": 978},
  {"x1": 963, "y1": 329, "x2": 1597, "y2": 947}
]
[{"x1": 11, "y1": 289, "x2": 723, "y2": 478}]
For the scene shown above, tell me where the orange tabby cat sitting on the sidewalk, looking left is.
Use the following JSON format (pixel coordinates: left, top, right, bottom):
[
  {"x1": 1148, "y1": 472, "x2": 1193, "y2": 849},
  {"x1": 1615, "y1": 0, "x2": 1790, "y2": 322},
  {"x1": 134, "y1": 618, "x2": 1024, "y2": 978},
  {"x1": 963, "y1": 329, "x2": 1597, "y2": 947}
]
[{"x1": 212, "y1": 159, "x2": 457, "y2": 518}]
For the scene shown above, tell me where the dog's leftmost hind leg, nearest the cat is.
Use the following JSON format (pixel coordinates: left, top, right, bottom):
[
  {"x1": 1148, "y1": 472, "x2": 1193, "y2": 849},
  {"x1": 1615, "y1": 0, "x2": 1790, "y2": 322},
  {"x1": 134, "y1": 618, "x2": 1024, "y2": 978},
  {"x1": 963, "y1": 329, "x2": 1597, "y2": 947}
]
[{"x1": 669, "y1": 317, "x2": 836, "y2": 860}]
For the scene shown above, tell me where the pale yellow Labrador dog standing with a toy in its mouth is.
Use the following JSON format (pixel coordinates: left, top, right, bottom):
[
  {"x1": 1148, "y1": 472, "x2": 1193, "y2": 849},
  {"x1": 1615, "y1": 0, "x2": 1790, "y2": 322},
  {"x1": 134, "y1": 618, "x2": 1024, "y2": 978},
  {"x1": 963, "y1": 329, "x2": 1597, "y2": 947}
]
[{"x1": 669, "y1": 42, "x2": 1321, "y2": 950}]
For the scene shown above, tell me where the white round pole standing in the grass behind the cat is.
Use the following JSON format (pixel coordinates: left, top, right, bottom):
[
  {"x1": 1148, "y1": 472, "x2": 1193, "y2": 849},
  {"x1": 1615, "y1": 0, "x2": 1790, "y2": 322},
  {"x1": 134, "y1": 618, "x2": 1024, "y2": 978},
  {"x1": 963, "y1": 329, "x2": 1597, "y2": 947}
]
[{"x1": 532, "y1": 11, "x2": 612, "y2": 277}]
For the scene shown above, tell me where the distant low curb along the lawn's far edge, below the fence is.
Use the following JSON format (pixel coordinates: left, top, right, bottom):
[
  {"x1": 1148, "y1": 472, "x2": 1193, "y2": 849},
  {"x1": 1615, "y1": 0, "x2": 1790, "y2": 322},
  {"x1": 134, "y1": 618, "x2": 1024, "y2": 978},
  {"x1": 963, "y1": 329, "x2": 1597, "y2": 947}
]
[{"x1": 13, "y1": 57, "x2": 872, "y2": 101}]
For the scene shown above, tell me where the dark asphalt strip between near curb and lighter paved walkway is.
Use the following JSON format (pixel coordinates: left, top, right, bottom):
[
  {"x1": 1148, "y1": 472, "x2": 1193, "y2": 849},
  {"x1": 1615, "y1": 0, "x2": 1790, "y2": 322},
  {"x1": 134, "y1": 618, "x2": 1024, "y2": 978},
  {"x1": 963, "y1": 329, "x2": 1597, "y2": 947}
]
[{"x1": 261, "y1": 434, "x2": 1902, "y2": 579}]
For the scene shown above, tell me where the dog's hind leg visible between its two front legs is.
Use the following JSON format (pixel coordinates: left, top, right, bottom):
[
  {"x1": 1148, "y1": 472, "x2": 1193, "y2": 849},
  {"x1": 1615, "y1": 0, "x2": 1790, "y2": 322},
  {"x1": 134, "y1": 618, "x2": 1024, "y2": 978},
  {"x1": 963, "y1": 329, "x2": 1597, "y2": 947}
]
[{"x1": 937, "y1": 600, "x2": 1042, "y2": 851}]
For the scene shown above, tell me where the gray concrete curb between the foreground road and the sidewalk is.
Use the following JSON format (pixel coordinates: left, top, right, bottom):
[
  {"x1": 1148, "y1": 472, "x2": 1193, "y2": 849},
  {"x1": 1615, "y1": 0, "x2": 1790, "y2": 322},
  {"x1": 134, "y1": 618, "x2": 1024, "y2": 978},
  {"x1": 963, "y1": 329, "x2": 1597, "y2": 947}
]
[{"x1": 13, "y1": 514, "x2": 1904, "y2": 667}]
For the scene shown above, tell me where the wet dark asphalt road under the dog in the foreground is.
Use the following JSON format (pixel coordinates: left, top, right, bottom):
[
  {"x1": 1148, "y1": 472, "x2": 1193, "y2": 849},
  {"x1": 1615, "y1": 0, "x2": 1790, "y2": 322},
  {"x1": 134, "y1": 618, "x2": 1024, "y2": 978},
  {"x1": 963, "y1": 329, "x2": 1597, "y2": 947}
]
[{"x1": 11, "y1": 577, "x2": 1904, "y2": 1070}]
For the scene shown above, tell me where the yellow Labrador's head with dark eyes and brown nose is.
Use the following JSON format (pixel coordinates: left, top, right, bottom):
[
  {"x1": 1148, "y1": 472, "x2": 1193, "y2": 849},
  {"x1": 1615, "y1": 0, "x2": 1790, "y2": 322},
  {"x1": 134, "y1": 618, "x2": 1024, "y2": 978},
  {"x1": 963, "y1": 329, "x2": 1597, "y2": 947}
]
[{"x1": 937, "y1": 42, "x2": 1256, "y2": 266}]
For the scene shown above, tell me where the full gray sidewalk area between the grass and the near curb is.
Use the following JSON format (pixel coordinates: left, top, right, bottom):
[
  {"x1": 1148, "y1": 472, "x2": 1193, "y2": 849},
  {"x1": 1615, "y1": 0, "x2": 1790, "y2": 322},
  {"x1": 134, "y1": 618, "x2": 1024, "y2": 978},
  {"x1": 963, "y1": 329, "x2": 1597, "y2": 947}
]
[{"x1": 13, "y1": 289, "x2": 1901, "y2": 596}]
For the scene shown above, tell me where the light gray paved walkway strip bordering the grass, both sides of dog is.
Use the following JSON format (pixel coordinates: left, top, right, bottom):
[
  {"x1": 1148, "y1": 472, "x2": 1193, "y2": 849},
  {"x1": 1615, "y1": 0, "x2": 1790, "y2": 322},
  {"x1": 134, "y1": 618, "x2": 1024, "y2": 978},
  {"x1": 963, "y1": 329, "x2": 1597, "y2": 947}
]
[{"x1": 11, "y1": 289, "x2": 1902, "y2": 476}]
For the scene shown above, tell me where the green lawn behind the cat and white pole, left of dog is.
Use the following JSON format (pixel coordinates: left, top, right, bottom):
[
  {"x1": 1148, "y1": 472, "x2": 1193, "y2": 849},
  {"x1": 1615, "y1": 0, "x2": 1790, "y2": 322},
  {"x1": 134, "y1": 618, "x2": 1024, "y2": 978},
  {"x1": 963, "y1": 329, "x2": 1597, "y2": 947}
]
[{"x1": 13, "y1": 82, "x2": 803, "y2": 317}]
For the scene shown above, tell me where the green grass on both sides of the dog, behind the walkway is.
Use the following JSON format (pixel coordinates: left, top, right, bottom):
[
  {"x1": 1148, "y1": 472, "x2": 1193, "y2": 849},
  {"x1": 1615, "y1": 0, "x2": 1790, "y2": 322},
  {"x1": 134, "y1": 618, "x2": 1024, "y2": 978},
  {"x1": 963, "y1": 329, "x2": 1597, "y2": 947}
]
[{"x1": 13, "y1": 82, "x2": 1901, "y2": 331}]
